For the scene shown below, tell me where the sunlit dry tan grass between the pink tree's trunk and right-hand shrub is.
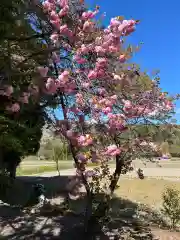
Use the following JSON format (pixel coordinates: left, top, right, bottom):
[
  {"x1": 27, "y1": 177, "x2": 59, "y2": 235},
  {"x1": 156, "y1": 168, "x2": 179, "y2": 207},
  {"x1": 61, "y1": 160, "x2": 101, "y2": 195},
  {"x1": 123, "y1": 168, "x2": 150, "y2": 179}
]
[{"x1": 115, "y1": 179, "x2": 180, "y2": 207}]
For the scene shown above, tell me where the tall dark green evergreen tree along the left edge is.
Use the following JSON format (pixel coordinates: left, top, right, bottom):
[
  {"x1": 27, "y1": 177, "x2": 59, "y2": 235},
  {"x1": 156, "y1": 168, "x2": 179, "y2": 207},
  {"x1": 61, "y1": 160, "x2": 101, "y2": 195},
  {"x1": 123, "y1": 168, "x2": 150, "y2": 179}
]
[{"x1": 0, "y1": 0, "x2": 47, "y2": 176}]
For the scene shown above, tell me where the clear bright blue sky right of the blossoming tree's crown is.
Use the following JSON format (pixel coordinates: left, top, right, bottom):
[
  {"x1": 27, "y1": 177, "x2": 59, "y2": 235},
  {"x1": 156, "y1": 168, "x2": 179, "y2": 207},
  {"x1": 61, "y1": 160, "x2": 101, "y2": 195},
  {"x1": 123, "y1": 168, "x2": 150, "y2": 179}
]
[{"x1": 87, "y1": 0, "x2": 180, "y2": 123}]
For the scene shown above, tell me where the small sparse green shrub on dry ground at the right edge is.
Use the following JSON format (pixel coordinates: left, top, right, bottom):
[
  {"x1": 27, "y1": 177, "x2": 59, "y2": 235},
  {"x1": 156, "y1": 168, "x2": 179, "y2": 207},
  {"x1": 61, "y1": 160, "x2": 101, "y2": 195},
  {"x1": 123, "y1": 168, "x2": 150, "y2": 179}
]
[{"x1": 162, "y1": 188, "x2": 180, "y2": 228}]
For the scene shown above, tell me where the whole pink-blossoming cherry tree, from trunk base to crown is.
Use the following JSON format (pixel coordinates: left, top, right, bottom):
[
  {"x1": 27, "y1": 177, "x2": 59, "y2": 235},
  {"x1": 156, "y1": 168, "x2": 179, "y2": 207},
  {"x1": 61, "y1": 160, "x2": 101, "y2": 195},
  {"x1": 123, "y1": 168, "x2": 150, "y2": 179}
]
[{"x1": 0, "y1": 0, "x2": 174, "y2": 234}]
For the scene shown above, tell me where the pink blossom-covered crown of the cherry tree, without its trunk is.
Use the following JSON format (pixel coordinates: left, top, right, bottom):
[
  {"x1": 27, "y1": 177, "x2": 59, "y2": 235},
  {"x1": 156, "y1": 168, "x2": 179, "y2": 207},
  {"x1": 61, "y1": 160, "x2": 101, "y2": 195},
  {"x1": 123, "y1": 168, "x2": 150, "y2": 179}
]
[{"x1": 0, "y1": 0, "x2": 173, "y2": 172}]
